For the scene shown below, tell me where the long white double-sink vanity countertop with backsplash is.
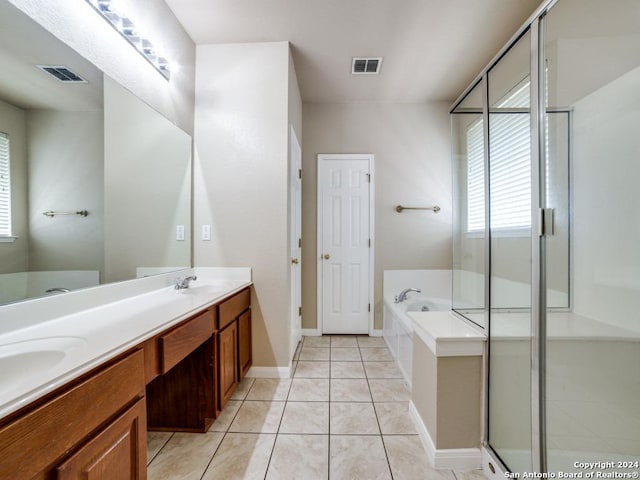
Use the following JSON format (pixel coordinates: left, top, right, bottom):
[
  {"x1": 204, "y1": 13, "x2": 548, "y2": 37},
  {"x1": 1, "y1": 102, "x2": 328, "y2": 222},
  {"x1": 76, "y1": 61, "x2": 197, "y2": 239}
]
[{"x1": 0, "y1": 268, "x2": 251, "y2": 417}]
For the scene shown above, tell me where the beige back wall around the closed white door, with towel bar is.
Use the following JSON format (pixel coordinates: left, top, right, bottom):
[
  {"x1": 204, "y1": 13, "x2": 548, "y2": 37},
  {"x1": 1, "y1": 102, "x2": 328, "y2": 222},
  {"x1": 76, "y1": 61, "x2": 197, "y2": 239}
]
[{"x1": 302, "y1": 102, "x2": 451, "y2": 329}]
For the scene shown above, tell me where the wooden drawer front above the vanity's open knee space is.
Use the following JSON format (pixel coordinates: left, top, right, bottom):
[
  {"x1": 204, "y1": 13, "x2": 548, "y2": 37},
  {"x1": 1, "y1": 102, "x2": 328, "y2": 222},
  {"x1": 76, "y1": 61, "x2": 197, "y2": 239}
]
[{"x1": 160, "y1": 310, "x2": 214, "y2": 373}]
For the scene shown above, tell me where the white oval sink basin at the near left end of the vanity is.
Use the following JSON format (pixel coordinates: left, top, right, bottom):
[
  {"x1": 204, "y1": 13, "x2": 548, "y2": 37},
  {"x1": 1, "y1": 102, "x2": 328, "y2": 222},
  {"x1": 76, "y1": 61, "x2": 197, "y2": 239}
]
[{"x1": 0, "y1": 337, "x2": 86, "y2": 390}]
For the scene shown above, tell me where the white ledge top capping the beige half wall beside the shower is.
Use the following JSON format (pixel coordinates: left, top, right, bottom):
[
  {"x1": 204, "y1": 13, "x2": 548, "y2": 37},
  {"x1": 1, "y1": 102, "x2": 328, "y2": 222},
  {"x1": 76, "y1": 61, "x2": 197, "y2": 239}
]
[{"x1": 407, "y1": 311, "x2": 486, "y2": 357}]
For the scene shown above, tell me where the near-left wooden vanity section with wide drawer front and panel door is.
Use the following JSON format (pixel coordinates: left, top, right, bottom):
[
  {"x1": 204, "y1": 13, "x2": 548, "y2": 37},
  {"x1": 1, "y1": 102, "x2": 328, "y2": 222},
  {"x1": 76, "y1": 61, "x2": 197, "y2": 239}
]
[{"x1": 0, "y1": 350, "x2": 147, "y2": 480}]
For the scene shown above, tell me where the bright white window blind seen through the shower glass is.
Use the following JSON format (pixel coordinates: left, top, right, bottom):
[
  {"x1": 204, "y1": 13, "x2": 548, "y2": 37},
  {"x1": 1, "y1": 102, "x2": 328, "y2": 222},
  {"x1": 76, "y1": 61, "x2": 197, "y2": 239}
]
[{"x1": 467, "y1": 79, "x2": 531, "y2": 232}]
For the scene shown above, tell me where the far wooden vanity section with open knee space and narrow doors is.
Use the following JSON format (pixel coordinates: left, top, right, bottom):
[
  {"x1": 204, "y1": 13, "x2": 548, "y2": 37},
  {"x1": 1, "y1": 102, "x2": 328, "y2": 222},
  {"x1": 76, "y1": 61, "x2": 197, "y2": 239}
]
[{"x1": 145, "y1": 288, "x2": 251, "y2": 432}]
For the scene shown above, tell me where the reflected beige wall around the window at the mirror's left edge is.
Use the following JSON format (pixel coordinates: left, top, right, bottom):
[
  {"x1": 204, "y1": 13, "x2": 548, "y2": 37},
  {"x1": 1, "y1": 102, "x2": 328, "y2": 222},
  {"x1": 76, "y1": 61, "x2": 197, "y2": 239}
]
[{"x1": 0, "y1": 100, "x2": 29, "y2": 273}]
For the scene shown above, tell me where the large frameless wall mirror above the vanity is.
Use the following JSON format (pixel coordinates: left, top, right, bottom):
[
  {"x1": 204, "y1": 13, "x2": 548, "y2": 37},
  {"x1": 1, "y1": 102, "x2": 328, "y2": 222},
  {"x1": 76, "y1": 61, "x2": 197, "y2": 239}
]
[{"x1": 0, "y1": 1, "x2": 191, "y2": 304}]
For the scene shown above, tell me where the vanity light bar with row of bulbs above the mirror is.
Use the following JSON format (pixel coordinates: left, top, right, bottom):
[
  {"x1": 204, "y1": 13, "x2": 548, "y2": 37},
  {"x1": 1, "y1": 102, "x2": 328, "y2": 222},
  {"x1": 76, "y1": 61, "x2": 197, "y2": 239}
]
[{"x1": 86, "y1": 0, "x2": 171, "y2": 80}]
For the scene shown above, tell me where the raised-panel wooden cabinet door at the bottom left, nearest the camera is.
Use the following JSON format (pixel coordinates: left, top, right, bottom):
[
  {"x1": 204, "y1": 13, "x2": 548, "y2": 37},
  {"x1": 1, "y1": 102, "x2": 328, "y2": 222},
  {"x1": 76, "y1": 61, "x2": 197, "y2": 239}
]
[{"x1": 56, "y1": 399, "x2": 147, "y2": 480}]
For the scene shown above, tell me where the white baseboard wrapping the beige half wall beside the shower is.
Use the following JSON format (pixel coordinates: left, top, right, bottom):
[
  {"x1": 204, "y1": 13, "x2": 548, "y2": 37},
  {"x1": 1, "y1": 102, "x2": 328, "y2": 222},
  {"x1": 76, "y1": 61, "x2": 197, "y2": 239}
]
[{"x1": 409, "y1": 400, "x2": 482, "y2": 470}]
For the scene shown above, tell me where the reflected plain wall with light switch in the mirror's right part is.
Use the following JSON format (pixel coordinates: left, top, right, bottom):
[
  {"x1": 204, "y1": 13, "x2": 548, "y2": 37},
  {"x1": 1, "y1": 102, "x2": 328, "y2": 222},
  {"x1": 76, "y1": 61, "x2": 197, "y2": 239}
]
[{"x1": 101, "y1": 77, "x2": 191, "y2": 282}]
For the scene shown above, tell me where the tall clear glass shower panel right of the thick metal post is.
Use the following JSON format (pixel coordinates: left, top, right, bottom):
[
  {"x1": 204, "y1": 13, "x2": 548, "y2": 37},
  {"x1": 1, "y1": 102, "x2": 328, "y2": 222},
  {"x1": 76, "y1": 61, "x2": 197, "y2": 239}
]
[{"x1": 541, "y1": 0, "x2": 640, "y2": 472}]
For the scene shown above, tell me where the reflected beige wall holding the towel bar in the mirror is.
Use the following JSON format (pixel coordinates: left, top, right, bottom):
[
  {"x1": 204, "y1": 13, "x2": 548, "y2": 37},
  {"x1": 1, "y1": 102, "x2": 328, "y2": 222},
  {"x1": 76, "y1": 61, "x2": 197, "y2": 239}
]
[{"x1": 27, "y1": 110, "x2": 104, "y2": 271}]
